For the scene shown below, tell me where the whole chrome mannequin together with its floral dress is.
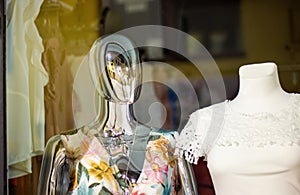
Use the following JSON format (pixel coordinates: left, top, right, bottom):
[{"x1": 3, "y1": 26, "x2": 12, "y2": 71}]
[{"x1": 38, "y1": 34, "x2": 195, "y2": 194}]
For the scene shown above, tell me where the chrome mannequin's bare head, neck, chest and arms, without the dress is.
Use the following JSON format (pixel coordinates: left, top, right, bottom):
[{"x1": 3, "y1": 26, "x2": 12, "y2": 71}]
[{"x1": 38, "y1": 34, "x2": 198, "y2": 194}]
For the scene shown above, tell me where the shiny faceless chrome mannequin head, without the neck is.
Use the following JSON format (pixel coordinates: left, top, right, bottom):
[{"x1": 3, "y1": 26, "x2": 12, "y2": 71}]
[{"x1": 89, "y1": 34, "x2": 142, "y2": 104}]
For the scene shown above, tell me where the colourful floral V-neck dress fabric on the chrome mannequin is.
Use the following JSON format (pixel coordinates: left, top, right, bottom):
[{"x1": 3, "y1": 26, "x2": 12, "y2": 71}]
[{"x1": 56, "y1": 130, "x2": 177, "y2": 195}]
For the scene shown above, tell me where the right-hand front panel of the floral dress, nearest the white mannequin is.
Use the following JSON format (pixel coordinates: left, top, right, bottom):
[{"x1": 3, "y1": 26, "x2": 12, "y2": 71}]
[{"x1": 133, "y1": 133, "x2": 177, "y2": 195}]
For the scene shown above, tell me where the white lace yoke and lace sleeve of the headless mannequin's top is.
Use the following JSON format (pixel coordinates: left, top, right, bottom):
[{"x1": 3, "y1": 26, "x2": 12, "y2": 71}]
[{"x1": 176, "y1": 94, "x2": 300, "y2": 163}]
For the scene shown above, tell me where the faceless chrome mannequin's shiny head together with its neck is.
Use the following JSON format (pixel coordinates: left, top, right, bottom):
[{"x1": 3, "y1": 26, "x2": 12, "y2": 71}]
[{"x1": 89, "y1": 34, "x2": 142, "y2": 137}]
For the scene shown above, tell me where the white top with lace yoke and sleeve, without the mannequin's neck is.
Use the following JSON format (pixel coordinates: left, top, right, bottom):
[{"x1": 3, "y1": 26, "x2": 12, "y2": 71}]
[{"x1": 176, "y1": 94, "x2": 300, "y2": 195}]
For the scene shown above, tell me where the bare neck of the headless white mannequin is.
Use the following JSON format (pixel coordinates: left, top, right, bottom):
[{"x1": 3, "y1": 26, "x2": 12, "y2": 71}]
[{"x1": 231, "y1": 63, "x2": 288, "y2": 113}]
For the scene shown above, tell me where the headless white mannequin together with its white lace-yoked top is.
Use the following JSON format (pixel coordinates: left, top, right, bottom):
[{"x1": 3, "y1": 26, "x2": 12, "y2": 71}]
[{"x1": 176, "y1": 62, "x2": 300, "y2": 195}]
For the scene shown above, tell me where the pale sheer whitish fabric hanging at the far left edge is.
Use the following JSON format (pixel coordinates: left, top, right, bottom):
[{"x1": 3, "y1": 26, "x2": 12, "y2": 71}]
[{"x1": 6, "y1": 0, "x2": 48, "y2": 178}]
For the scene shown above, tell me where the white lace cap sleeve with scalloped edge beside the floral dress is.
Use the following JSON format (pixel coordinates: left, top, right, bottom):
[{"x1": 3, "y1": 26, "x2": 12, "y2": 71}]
[{"x1": 176, "y1": 103, "x2": 225, "y2": 164}]
